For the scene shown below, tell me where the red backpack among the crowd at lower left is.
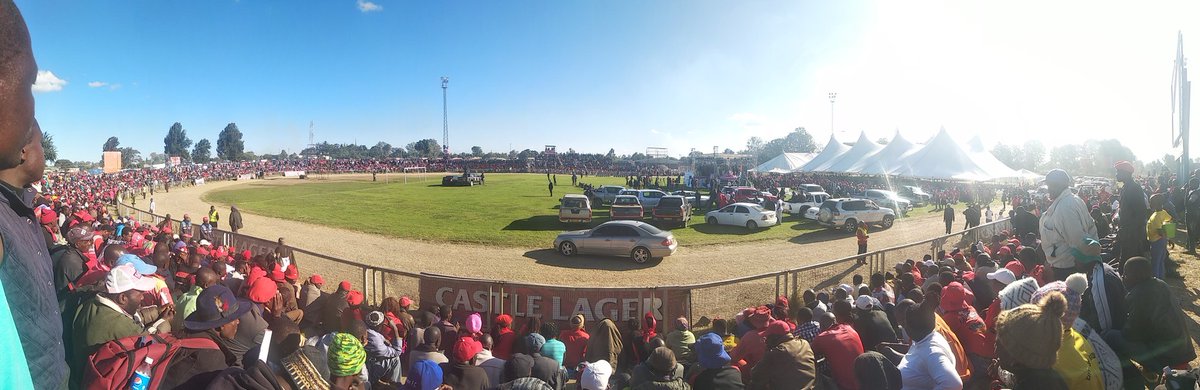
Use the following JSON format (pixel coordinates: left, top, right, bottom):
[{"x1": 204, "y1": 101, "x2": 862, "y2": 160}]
[{"x1": 83, "y1": 334, "x2": 221, "y2": 390}]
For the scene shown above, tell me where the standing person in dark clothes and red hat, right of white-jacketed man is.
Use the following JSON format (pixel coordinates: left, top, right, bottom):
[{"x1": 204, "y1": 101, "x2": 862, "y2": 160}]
[{"x1": 1108, "y1": 160, "x2": 1150, "y2": 264}]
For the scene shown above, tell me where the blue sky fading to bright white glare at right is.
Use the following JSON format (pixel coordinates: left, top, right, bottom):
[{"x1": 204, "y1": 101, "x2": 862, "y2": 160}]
[{"x1": 17, "y1": 0, "x2": 1200, "y2": 160}]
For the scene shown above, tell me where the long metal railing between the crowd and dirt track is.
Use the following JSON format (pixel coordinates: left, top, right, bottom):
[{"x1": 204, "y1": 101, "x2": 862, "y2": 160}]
[{"x1": 118, "y1": 200, "x2": 1012, "y2": 323}]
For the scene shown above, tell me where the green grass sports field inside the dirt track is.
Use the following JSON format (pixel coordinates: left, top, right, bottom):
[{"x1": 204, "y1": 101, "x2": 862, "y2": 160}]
[{"x1": 204, "y1": 174, "x2": 835, "y2": 247}]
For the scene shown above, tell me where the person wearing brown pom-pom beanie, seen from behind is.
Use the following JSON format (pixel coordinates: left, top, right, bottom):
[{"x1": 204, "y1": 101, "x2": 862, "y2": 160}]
[{"x1": 996, "y1": 288, "x2": 1068, "y2": 390}]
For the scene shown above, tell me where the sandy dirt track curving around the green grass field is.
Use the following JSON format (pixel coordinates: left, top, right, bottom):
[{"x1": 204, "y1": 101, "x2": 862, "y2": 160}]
[{"x1": 147, "y1": 175, "x2": 961, "y2": 287}]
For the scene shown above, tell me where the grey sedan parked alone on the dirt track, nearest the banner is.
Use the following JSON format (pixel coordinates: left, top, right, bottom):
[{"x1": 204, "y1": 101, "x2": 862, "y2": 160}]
[{"x1": 554, "y1": 221, "x2": 679, "y2": 264}]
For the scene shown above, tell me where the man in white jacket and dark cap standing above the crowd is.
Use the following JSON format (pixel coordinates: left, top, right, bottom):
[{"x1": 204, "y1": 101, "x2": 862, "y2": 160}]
[{"x1": 1039, "y1": 169, "x2": 1096, "y2": 281}]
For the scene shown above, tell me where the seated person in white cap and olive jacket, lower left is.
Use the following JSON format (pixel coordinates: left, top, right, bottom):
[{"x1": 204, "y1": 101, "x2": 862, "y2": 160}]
[{"x1": 70, "y1": 265, "x2": 174, "y2": 384}]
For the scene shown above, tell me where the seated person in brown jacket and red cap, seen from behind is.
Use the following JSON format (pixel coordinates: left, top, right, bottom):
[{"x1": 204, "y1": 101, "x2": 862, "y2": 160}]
[{"x1": 750, "y1": 321, "x2": 816, "y2": 389}]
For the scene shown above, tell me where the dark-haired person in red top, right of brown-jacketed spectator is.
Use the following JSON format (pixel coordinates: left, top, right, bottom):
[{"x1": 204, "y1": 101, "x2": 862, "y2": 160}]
[{"x1": 812, "y1": 301, "x2": 863, "y2": 390}]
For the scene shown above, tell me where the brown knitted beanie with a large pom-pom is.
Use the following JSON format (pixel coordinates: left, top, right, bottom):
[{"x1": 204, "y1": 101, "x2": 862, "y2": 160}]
[{"x1": 996, "y1": 292, "x2": 1067, "y2": 368}]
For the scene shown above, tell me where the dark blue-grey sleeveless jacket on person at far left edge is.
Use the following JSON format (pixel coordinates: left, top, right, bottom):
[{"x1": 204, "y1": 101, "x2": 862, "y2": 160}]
[{"x1": 0, "y1": 181, "x2": 68, "y2": 389}]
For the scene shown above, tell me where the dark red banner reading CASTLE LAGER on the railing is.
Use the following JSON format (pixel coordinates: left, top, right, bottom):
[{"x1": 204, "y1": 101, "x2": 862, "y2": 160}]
[{"x1": 420, "y1": 274, "x2": 689, "y2": 329}]
